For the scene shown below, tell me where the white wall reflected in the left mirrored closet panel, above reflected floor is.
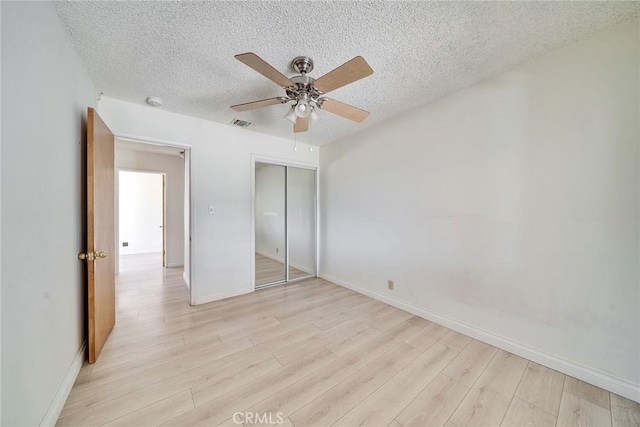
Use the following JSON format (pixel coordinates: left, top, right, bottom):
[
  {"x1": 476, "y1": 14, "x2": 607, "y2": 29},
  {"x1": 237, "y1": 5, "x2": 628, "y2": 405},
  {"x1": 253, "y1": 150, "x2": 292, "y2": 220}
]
[{"x1": 255, "y1": 164, "x2": 286, "y2": 262}]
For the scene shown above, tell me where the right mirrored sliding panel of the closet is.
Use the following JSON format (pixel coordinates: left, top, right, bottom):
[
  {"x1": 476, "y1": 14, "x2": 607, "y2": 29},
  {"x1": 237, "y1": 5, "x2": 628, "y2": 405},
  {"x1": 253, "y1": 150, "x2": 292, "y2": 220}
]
[{"x1": 287, "y1": 167, "x2": 316, "y2": 280}]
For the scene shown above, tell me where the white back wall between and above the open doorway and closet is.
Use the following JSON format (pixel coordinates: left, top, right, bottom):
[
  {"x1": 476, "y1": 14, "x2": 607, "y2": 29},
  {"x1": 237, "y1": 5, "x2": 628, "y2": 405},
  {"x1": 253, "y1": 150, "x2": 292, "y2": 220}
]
[{"x1": 99, "y1": 97, "x2": 318, "y2": 304}]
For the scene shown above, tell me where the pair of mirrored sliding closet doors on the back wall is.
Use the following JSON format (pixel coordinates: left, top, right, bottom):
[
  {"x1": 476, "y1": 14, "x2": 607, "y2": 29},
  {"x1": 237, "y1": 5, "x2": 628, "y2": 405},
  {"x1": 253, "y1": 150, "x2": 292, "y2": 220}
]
[{"x1": 254, "y1": 162, "x2": 316, "y2": 288}]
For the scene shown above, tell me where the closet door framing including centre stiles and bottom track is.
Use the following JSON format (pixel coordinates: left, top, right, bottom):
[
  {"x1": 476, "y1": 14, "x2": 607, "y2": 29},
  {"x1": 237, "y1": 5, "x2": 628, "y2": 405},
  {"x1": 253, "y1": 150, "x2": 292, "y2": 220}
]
[{"x1": 249, "y1": 154, "x2": 320, "y2": 291}]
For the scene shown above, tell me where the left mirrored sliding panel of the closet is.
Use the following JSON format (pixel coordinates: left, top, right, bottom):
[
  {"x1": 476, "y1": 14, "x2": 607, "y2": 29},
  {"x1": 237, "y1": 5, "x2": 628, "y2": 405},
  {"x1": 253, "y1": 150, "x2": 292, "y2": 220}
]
[{"x1": 255, "y1": 163, "x2": 286, "y2": 286}]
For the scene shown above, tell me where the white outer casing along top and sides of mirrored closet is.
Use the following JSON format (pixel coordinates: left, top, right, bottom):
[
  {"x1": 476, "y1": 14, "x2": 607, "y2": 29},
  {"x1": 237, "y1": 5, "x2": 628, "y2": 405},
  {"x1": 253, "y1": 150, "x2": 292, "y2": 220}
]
[{"x1": 249, "y1": 154, "x2": 320, "y2": 292}]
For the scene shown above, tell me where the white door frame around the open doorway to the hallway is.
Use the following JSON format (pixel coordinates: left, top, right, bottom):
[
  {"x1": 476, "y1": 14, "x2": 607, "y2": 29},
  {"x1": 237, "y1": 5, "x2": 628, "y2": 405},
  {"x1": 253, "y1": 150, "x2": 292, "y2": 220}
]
[{"x1": 114, "y1": 133, "x2": 195, "y2": 305}]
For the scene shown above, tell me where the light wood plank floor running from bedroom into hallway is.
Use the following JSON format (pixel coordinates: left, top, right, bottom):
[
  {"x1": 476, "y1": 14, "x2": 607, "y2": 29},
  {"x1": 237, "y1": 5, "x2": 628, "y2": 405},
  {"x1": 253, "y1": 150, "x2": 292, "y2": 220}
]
[{"x1": 58, "y1": 256, "x2": 640, "y2": 427}]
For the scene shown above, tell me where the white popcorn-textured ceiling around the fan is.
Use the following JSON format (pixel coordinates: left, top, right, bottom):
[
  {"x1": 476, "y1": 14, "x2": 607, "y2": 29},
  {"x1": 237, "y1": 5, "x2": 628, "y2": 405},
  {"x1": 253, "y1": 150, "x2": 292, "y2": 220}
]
[{"x1": 55, "y1": 1, "x2": 640, "y2": 145}]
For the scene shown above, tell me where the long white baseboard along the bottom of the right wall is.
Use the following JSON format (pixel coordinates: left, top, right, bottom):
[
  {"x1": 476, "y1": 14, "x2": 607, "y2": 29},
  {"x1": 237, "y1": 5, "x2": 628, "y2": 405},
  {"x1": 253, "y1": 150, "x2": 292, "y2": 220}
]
[{"x1": 319, "y1": 274, "x2": 640, "y2": 402}]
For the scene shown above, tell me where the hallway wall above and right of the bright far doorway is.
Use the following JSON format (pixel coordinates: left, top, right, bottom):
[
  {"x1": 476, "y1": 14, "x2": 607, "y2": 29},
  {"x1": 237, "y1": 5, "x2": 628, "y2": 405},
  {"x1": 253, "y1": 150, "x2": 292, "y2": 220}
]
[{"x1": 115, "y1": 147, "x2": 185, "y2": 267}]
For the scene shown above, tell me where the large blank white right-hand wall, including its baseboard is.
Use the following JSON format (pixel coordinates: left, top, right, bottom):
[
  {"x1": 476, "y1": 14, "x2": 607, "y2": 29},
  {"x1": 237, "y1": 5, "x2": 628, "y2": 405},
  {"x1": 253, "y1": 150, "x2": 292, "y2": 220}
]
[{"x1": 320, "y1": 20, "x2": 640, "y2": 400}]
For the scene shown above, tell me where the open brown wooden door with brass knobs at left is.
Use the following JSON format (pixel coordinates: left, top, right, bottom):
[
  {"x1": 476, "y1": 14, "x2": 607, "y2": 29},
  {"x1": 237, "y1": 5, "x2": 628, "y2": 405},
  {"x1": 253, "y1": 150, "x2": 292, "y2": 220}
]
[{"x1": 86, "y1": 108, "x2": 116, "y2": 363}]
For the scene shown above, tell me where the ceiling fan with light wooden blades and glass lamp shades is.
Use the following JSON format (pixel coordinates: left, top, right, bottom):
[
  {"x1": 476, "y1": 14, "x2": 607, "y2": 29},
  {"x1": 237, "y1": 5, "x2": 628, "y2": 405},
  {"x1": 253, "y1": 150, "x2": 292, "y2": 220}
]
[{"x1": 231, "y1": 52, "x2": 373, "y2": 132}]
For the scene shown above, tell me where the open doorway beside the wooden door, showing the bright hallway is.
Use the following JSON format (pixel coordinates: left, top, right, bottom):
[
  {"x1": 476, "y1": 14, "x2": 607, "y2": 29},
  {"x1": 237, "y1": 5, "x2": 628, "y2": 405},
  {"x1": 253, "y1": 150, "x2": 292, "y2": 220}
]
[{"x1": 115, "y1": 137, "x2": 191, "y2": 294}]
